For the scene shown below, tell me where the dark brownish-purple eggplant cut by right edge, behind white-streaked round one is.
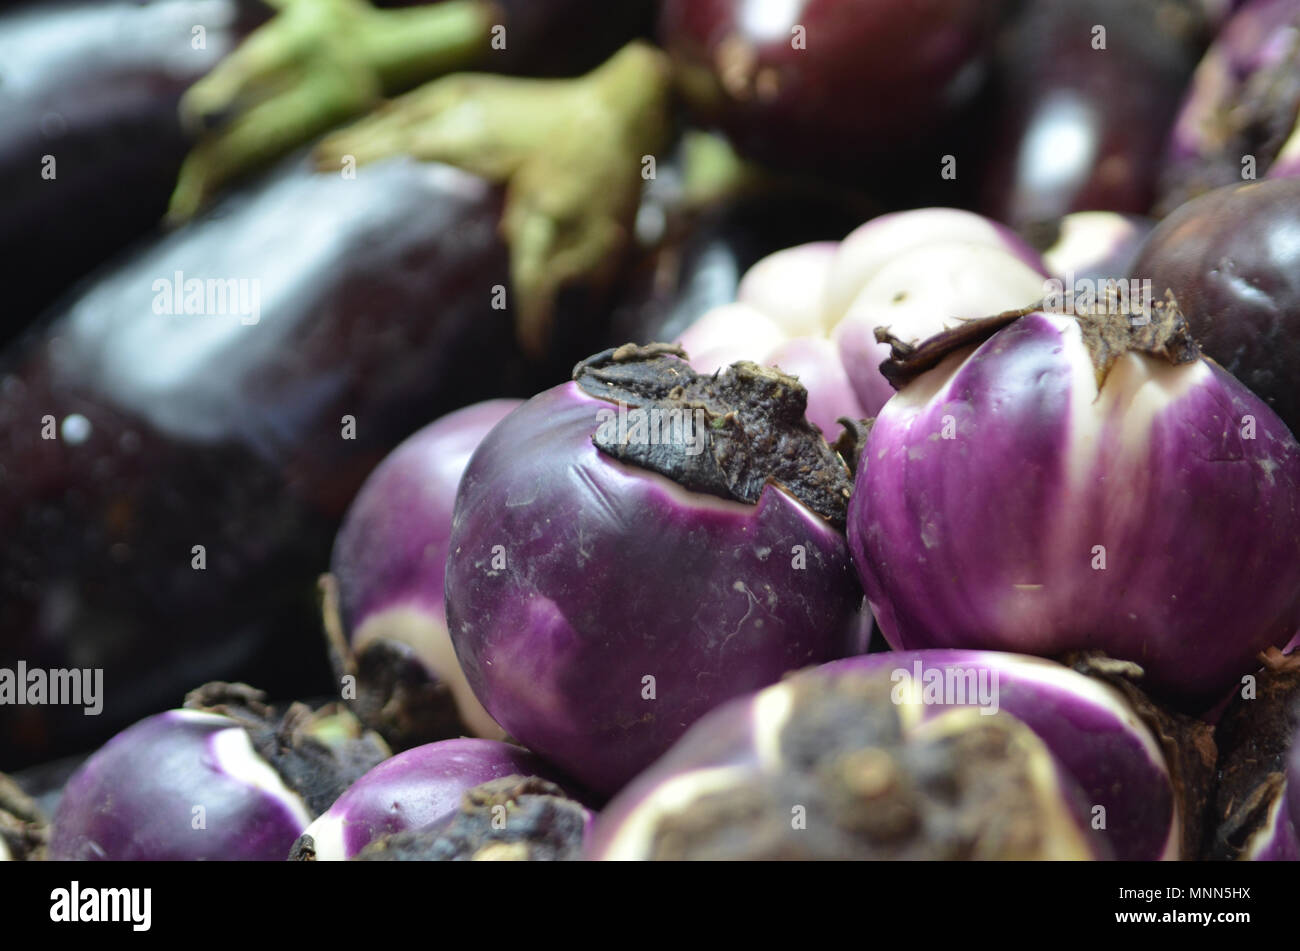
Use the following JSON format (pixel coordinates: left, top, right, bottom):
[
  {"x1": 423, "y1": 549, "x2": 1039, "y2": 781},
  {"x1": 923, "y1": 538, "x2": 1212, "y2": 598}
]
[{"x1": 1132, "y1": 178, "x2": 1300, "y2": 433}]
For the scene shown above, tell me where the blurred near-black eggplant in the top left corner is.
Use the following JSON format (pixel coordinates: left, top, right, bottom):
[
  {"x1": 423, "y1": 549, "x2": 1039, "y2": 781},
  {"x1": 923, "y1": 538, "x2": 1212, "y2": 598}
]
[{"x1": 0, "y1": 0, "x2": 269, "y2": 340}]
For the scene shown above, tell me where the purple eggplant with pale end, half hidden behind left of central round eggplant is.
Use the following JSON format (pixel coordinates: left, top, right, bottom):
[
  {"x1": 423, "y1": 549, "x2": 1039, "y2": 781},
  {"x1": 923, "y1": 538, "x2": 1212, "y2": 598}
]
[{"x1": 326, "y1": 400, "x2": 521, "y2": 747}]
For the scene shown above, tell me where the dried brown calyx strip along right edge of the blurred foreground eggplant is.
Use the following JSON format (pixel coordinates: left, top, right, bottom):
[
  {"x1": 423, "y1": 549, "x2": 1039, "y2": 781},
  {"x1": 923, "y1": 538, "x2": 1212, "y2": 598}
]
[{"x1": 1060, "y1": 651, "x2": 1218, "y2": 859}]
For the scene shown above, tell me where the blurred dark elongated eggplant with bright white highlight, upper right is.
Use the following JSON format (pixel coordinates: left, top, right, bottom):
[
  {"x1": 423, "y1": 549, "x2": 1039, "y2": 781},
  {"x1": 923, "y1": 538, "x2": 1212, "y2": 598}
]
[{"x1": 980, "y1": 0, "x2": 1209, "y2": 227}]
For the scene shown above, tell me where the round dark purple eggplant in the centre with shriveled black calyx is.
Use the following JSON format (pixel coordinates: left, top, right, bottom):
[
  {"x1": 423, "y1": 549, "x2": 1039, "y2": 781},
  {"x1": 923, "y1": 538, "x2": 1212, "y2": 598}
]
[{"x1": 447, "y1": 344, "x2": 861, "y2": 793}]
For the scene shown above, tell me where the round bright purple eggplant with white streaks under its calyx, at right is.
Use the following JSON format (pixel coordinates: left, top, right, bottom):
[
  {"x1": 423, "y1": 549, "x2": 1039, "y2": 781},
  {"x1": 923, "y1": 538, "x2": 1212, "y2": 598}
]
[{"x1": 849, "y1": 300, "x2": 1300, "y2": 703}]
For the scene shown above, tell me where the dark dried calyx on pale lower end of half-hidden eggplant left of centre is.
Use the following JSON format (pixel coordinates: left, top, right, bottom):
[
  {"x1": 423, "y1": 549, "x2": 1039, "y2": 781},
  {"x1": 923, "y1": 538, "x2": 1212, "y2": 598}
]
[{"x1": 319, "y1": 574, "x2": 469, "y2": 752}]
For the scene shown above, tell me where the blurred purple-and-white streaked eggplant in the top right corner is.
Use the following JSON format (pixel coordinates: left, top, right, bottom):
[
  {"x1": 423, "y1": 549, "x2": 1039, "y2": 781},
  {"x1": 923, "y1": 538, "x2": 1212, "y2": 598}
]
[{"x1": 1161, "y1": 0, "x2": 1300, "y2": 212}]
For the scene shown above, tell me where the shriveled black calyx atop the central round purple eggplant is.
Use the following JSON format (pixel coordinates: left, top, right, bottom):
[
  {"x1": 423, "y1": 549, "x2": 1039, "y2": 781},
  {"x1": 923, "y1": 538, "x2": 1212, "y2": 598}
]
[{"x1": 573, "y1": 343, "x2": 853, "y2": 530}]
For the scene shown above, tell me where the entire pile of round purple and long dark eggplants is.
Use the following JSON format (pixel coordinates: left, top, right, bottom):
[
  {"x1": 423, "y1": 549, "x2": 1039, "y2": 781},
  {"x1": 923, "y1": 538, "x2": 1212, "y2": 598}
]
[{"x1": 12, "y1": 0, "x2": 1300, "y2": 861}]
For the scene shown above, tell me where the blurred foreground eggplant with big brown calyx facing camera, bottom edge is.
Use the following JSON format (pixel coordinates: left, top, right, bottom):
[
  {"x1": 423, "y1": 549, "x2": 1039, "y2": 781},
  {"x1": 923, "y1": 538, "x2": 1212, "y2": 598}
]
[{"x1": 588, "y1": 651, "x2": 1149, "y2": 860}]
